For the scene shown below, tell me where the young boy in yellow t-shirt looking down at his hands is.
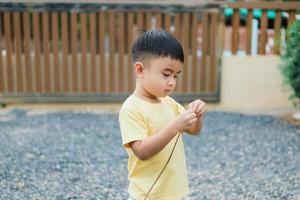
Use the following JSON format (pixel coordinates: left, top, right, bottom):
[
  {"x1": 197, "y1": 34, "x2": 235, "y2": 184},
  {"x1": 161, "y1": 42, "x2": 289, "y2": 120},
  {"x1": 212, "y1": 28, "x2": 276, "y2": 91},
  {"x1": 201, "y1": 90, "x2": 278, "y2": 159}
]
[{"x1": 119, "y1": 30, "x2": 205, "y2": 200}]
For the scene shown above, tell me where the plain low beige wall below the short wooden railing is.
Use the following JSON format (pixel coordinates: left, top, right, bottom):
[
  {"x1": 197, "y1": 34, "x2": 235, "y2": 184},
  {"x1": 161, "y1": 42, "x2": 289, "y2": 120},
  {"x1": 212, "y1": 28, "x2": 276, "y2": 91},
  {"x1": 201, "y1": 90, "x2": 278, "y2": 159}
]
[{"x1": 215, "y1": 56, "x2": 292, "y2": 111}]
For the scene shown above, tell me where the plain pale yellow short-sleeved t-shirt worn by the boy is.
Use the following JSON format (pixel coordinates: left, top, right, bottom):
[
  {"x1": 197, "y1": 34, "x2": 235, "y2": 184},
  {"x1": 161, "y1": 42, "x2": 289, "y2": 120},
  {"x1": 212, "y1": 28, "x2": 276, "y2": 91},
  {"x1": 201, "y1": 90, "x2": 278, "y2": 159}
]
[{"x1": 119, "y1": 95, "x2": 189, "y2": 200}]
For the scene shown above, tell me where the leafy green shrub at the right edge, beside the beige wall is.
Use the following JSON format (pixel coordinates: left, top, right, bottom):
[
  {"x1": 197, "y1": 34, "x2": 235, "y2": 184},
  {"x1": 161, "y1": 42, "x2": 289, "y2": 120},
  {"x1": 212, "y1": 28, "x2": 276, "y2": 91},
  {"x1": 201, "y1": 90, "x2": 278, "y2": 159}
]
[{"x1": 280, "y1": 20, "x2": 300, "y2": 108}]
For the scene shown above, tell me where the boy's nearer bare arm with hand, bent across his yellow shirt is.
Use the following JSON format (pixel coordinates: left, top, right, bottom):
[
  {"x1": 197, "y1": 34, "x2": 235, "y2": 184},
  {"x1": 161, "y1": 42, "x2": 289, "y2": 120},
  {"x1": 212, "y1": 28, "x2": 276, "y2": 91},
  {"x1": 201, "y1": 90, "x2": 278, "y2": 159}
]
[{"x1": 129, "y1": 108, "x2": 197, "y2": 160}]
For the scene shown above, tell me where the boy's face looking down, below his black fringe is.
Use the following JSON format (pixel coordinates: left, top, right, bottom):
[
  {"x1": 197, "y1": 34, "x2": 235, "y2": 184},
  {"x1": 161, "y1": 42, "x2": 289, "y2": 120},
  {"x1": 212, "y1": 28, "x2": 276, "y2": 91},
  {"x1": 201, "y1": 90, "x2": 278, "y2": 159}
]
[{"x1": 139, "y1": 57, "x2": 181, "y2": 97}]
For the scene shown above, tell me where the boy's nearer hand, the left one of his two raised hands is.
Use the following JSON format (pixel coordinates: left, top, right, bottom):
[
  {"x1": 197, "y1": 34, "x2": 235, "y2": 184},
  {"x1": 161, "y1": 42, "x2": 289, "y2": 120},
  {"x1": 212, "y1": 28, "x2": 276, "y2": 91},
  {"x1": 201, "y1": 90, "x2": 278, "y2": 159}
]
[{"x1": 175, "y1": 109, "x2": 197, "y2": 132}]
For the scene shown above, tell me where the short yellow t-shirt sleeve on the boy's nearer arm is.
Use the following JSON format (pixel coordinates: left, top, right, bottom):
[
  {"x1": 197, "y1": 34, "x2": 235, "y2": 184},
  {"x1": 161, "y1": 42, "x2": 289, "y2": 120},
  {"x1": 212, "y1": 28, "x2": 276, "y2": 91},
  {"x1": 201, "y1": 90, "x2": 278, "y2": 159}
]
[{"x1": 119, "y1": 109, "x2": 148, "y2": 148}]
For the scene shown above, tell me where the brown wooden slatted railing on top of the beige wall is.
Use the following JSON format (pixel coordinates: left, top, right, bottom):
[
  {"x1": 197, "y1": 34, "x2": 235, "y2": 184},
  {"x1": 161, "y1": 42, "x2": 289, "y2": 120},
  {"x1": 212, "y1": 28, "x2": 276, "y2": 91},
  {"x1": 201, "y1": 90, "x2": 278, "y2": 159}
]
[{"x1": 223, "y1": 2, "x2": 300, "y2": 55}]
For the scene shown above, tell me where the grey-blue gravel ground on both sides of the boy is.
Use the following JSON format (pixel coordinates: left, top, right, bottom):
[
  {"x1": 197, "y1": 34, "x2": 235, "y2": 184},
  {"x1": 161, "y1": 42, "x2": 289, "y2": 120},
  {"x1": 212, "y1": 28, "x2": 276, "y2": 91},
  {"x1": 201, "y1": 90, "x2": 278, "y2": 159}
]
[{"x1": 0, "y1": 109, "x2": 300, "y2": 200}]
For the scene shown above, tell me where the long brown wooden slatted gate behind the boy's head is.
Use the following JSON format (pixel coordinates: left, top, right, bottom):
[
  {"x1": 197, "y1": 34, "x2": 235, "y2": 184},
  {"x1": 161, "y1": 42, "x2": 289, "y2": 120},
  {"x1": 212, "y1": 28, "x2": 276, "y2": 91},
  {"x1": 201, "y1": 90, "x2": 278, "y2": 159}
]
[{"x1": 0, "y1": 4, "x2": 222, "y2": 102}]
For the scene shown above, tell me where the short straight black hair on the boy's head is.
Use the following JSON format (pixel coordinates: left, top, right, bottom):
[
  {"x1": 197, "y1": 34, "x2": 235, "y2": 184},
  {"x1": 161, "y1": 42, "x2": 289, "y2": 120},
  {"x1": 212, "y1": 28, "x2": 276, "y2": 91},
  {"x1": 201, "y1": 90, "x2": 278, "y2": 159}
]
[{"x1": 132, "y1": 29, "x2": 184, "y2": 63}]
